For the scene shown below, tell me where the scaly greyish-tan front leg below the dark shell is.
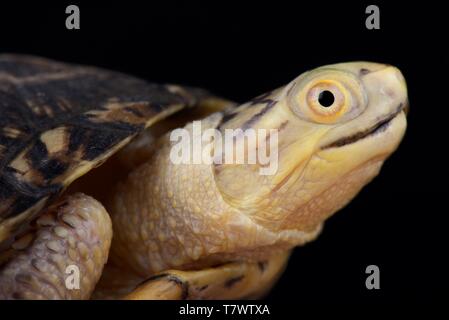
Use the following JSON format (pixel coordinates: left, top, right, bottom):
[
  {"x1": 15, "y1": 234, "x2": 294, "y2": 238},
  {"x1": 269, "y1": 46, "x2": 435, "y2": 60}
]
[{"x1": 0, "y1": 194, "x2": 112, "y2": 299}]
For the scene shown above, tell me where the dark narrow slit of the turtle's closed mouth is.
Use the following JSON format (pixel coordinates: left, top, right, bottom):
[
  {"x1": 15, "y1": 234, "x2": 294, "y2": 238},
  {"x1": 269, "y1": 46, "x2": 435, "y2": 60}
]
[{"x1": 321, "y1": 102, "x2": 408, "y2": 150}]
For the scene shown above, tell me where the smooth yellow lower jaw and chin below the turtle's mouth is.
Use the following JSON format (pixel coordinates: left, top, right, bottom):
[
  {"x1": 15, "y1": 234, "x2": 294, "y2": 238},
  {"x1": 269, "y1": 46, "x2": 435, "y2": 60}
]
[{"x1": 270, "y1": 112, "x2": 406, "y2": 231}]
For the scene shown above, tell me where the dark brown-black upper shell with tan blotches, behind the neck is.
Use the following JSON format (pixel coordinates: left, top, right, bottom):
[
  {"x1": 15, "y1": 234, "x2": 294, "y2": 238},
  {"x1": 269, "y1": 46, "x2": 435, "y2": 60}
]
[{"x1": 0, "y1": 55, "x2": 212, "y2": 244}]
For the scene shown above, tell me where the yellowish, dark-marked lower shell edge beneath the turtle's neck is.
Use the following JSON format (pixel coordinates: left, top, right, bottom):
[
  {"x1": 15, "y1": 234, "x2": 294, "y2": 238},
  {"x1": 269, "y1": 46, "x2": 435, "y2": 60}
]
[{"x1": 124, "y1": 252, "x2": 290, "y2": 300}]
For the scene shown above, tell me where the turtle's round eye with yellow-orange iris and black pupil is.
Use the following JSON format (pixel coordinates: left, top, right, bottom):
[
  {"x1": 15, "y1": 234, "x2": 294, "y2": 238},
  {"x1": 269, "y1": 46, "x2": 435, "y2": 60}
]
[{"x1": 306, "y1": 80, "x2": 348, "y2": 123}]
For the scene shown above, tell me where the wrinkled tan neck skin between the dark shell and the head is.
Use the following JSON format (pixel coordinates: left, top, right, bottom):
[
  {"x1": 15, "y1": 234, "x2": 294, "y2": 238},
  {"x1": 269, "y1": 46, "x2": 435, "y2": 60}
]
[{"x1": 107, "y1": 113, "x2": 321, "y2": 276}]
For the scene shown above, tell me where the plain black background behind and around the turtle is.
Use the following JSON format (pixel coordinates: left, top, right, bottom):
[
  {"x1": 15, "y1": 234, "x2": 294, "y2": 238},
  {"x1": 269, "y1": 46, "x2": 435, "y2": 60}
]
[{"x1": 0, "y1": 1, "x2": 449, "y2": 304}]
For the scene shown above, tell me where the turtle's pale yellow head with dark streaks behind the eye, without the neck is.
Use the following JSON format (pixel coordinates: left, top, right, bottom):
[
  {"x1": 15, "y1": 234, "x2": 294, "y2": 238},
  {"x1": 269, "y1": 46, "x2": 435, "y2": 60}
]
[{"x1": 215, "y1": 62, "x2": 408, "y2": 232}]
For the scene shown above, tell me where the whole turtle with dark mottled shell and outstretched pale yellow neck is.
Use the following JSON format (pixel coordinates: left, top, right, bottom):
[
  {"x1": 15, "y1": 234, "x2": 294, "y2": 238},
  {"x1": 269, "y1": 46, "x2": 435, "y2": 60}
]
[{"x1": 0, "y1": 54, "x2": 408, "y2": 300}]
